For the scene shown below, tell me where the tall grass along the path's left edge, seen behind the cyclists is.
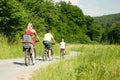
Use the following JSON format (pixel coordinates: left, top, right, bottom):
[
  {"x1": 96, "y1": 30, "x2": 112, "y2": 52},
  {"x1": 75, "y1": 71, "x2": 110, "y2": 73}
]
[{"x1": 0, "y1": 34, "x2": 59, "y2": 59}]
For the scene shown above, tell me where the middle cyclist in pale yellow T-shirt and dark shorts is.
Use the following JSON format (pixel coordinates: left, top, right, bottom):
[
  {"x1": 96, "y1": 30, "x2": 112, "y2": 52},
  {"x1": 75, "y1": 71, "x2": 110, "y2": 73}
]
[{"x1": 43, "y1": 30, "x2": 55, "y2": 60}]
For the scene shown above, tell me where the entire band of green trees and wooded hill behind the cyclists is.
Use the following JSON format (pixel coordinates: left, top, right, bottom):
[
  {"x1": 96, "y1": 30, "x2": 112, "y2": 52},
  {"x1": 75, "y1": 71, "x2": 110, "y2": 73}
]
[{"x1": 0, "y1": 0, "x2": 120, "y2": 44}]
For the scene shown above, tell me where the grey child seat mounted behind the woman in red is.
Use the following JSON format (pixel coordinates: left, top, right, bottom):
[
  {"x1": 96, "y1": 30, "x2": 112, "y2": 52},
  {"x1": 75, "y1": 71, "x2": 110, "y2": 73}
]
[{"x1": 22, "y1": 34, "x2": 32, "y2": 48}]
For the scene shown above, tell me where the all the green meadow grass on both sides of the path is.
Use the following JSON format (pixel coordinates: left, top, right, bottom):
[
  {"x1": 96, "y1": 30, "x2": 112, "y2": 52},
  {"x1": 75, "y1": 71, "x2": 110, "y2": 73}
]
[{"x1": 0, "y1": 35, "x2": 120, "y2": 80}]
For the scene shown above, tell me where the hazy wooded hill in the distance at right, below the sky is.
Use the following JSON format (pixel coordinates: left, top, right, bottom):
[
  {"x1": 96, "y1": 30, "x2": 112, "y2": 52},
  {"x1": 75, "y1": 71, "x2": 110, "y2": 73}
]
[{"x1": 93, "y1": 13, "x2": 120, "y2": 28}]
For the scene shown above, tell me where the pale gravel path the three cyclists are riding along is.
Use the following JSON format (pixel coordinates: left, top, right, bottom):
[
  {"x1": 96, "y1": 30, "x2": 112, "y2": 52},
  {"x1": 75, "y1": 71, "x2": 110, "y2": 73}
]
[{"x1": 0, "y1": 52, "x2": 78, "y2": 80}]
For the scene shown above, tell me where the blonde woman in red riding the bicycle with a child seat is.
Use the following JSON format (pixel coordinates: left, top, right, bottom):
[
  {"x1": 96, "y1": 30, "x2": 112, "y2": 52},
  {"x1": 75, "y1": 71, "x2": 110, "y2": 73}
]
[{"x1": 25, "y1": 23, "x2": 40, "y2": 64}]
